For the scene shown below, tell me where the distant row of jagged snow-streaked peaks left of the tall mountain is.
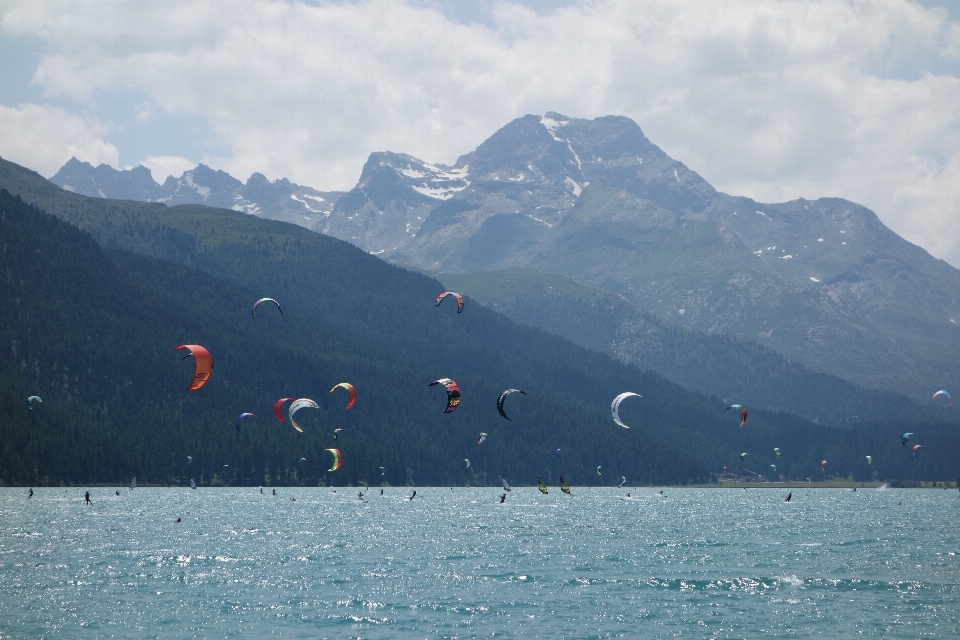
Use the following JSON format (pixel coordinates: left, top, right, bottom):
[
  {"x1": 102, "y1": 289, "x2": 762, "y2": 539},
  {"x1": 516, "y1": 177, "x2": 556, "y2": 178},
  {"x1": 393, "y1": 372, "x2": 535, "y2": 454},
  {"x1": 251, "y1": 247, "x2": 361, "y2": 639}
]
[{"x1": 50, "y1": 158, "x2": 343, "y2": 229}]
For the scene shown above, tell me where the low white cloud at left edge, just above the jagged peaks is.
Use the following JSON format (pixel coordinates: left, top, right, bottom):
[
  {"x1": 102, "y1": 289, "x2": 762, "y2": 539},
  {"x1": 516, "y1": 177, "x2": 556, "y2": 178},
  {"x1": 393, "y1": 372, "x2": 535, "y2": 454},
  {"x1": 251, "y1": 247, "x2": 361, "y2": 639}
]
[{"x1": 0, "y1": 104, "x2": 120, "y2": 176}]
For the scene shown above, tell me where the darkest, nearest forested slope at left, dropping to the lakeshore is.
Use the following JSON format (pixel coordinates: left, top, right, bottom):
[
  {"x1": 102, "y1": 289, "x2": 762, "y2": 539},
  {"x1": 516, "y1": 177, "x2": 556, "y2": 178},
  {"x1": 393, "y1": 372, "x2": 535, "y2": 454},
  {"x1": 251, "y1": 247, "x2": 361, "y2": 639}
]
[{"x1": 0, "y1": 191, "x2": 705, "y2": 485}]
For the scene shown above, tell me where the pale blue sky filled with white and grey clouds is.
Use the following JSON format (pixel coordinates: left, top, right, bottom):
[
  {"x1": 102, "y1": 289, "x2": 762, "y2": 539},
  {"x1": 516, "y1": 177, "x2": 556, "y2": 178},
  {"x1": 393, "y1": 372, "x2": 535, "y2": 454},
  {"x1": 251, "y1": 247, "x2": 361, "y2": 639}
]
[{"x1": 0, "y1": 0, "x2": 960, "y2": 267}]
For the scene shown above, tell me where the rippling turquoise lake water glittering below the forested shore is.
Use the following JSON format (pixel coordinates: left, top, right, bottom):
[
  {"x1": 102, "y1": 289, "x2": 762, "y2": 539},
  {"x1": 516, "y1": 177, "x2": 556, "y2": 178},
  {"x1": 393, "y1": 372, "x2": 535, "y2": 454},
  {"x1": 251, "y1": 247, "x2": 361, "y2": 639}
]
[{"x1": 0, "y1": 487, "x2": 960, "y2": 638}]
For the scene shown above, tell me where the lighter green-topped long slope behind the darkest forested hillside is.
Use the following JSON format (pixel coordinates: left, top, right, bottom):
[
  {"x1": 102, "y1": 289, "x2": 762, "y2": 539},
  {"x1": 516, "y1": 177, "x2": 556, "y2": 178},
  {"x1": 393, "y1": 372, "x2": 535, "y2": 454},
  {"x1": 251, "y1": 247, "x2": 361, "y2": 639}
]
[{"x1": 0, "y1": 164, "x2": 952, "y2": 479}]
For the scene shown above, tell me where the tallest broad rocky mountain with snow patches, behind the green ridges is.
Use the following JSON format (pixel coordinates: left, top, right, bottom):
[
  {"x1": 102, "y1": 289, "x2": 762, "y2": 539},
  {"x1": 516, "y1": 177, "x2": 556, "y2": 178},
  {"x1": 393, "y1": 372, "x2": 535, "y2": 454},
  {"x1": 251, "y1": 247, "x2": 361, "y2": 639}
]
[{"x1": 316, "y1": 112, "x2": 960, "y2": 400}]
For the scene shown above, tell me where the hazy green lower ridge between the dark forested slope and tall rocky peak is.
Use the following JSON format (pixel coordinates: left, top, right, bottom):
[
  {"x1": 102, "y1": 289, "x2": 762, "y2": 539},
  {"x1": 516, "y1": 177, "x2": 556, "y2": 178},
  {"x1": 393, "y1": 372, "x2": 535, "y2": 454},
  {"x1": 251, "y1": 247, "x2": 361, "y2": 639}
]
[{"x1": 439, "y1": 269, "x2": 944, "y2": 425}]
